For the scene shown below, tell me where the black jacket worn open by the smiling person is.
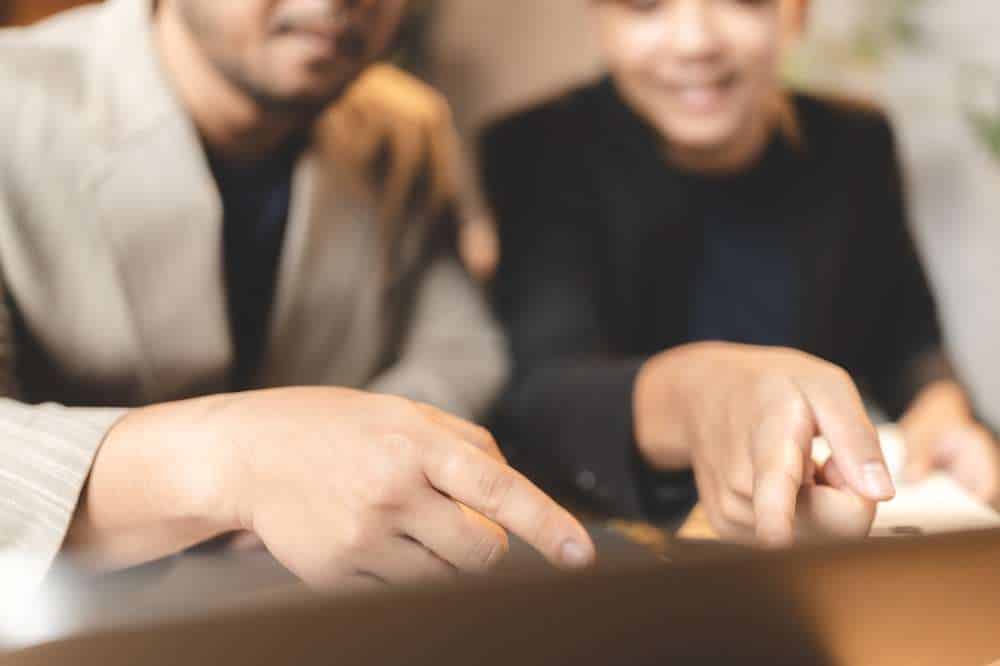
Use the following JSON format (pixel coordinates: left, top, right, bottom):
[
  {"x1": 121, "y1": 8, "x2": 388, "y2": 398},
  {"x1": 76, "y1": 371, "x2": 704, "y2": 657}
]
[{"x1": 481, "y1": 79, "x2": 948, "y2": 519}]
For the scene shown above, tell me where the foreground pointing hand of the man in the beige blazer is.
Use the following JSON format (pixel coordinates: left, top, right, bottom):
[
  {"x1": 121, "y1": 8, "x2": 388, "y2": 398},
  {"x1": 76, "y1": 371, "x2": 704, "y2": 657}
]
[{"x1": 70, "y1": 388, "x2": 594, "y2": 587}]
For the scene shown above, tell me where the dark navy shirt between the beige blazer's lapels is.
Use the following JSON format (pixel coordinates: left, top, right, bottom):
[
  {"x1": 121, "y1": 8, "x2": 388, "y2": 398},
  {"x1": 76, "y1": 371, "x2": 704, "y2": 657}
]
[{"x1": 209, "y1": 138, "x2": 304, "y2": 390}]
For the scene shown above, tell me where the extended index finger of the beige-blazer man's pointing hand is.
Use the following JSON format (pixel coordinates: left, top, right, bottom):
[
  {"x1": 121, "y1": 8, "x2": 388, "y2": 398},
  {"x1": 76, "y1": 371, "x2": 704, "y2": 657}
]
[{"x1": 424, "y1": 440, "x2": 595, "y2": 568}]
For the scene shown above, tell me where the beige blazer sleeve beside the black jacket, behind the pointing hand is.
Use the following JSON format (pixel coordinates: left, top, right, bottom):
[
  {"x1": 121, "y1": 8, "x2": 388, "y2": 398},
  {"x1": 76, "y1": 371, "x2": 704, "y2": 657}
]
[{"x1": 367, "y1": 210, "x2": 509, "y2": 419}]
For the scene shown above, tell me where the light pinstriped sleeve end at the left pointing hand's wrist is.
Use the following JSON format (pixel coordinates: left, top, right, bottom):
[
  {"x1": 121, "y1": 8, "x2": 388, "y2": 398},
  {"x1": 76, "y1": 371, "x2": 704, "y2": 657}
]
[{"x1": 0, "y1": 274, "x2": 124, "y2": 589}]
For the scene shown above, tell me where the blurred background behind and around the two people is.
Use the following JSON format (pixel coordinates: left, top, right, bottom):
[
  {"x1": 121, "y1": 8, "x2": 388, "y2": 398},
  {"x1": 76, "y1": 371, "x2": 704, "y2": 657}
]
[{"x1": 7, "y1": 0, "x2": 1000, "y2": 428}]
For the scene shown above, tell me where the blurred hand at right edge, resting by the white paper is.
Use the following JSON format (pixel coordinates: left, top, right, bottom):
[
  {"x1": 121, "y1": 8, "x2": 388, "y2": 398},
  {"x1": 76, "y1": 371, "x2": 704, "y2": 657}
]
[{"x1": 899, "y1": 381, "x2": 1000, "y2": 507}]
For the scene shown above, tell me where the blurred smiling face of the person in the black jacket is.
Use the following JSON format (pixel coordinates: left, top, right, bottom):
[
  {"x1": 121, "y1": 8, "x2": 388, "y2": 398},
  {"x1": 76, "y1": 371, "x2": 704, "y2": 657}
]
[{"x1": 593, "y1": 0, "x2": 803, "y2": 158}]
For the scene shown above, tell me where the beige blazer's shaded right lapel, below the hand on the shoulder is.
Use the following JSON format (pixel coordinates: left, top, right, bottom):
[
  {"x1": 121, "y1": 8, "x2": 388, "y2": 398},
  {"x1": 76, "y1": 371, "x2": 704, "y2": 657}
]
[{"x1": 258, "y1": 140, "x2": 383, "y2": 386}]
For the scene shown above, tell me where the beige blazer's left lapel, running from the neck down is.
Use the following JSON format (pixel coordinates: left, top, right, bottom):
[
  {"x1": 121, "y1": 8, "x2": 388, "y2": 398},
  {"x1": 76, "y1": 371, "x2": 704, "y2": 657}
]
[{"x1": 89, "y1": 0, "x2": 232, "y2": 400}]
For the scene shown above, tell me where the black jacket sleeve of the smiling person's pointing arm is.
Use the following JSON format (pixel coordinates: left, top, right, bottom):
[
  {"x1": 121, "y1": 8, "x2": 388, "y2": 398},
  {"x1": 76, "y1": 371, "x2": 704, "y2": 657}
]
[{"x1": 481, "y1": 119, "x2": 694, "y2": 521}]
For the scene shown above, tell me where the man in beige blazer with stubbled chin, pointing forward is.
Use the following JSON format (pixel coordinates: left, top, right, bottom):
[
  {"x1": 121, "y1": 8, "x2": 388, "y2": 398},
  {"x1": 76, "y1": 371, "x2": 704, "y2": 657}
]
[{"x1": 0, "y1": 0, "x2": 593, "y2": 585}]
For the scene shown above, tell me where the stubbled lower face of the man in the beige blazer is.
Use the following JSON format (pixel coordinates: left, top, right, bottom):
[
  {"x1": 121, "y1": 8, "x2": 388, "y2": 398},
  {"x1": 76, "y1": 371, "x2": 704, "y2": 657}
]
[{"x1": 168, "y1": 0, "x2": 406, "y2": 108}]
